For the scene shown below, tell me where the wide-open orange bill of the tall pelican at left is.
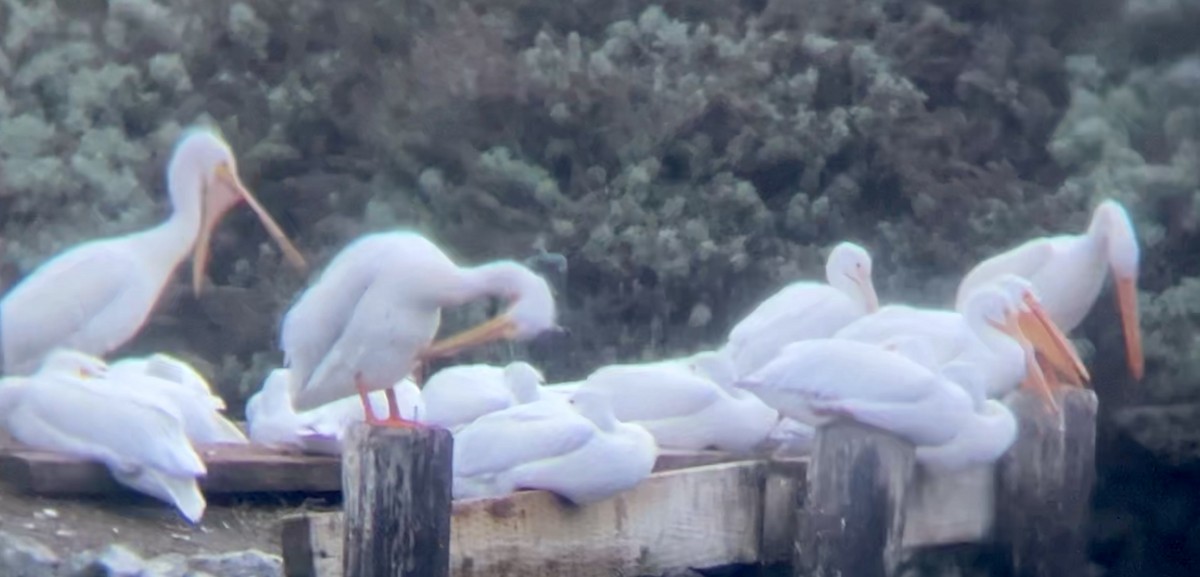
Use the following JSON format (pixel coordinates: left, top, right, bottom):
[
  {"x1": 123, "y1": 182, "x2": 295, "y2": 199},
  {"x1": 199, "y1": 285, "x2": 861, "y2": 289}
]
[{"x1": 192, "y1": 164, "x2": 308, "y2": 296}]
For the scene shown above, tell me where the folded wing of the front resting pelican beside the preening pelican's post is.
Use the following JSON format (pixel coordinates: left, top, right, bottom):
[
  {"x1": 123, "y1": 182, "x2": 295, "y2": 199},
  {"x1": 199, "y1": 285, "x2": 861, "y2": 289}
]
[{"x1": 454, "y1": 401, "x2": 595, "y2": 476}]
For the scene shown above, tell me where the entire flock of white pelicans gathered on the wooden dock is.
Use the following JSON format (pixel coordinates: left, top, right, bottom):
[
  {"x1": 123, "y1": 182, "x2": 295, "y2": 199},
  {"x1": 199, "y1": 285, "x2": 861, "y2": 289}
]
[{"x1": 0, "y1": 121, "x2": 1144, "y2": 523}]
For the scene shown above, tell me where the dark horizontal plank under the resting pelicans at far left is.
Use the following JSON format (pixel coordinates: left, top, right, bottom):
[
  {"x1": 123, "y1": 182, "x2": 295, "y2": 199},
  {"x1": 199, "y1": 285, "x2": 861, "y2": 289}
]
[{"x1": 0, "y1": 445, "x2": 341, "y2": 495}]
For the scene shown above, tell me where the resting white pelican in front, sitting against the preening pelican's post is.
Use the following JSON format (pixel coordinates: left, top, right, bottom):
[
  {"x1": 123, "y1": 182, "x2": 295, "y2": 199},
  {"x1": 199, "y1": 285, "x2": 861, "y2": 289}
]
[{"x1": 454, "y1": 390, "x2": 658, "y2": 505}]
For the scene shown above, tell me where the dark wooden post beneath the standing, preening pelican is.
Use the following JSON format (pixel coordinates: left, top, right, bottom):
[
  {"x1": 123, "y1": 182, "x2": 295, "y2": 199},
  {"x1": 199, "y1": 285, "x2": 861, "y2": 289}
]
[{"x1": 342, "y1": 423, "x2": 454, "y2": 577}]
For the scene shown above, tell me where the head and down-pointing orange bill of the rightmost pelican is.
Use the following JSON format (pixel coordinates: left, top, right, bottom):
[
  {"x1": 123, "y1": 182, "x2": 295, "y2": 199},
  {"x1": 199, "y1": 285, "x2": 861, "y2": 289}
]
[{"x1": 1087, "y1": 200, "x2": 1145, "y2": 379}]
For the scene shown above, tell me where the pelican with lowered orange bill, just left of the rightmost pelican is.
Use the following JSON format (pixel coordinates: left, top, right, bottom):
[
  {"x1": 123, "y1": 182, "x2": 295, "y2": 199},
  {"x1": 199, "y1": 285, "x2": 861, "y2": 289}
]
[{"x1": 834, "y1": 277, "x2": 1066, "y2": 408}]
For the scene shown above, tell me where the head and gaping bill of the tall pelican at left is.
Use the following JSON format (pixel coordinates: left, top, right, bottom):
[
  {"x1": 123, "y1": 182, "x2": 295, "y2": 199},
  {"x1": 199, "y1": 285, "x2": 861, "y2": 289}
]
[{"x1": 168, "y1": 127, "x2": 307, "y2": 295}]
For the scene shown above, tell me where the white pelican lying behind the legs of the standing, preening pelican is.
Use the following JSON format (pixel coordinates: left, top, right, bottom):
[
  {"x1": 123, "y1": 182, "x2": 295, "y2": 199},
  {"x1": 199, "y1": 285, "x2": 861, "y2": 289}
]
[{"x1": 246, "y1": 368, "x2": 425, "y2": 455}]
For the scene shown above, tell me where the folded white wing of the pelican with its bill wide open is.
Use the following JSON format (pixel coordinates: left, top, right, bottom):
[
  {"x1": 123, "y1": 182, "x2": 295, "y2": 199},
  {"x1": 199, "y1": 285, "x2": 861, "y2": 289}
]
[{"x1": 0, "y1": 244, "x2": 152, "y2": 373}]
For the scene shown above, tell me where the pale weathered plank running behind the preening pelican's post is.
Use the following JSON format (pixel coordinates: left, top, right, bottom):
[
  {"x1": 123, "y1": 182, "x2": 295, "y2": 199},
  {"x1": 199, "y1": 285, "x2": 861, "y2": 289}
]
[{"x1": 283, "y1": 461, "x2": 787, "y2": 577}]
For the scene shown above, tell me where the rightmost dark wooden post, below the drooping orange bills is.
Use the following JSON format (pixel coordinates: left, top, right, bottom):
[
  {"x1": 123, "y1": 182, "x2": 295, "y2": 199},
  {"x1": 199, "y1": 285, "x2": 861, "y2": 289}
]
[{"x1": 994, "y1": 389, "x2": 1097, "y2": 577}]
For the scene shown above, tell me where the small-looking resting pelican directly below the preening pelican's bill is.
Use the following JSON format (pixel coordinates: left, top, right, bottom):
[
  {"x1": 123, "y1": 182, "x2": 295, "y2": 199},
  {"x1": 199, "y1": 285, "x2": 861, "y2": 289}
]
[{"x1": 421, "y1": 361, "x2": 545, "y2": 431}]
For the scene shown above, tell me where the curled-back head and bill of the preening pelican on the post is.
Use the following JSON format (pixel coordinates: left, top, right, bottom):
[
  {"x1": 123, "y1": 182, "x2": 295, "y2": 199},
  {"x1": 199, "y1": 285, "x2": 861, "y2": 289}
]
[{"x1": 421, "y1": 260, "x2": 562, "y2": 359}]
